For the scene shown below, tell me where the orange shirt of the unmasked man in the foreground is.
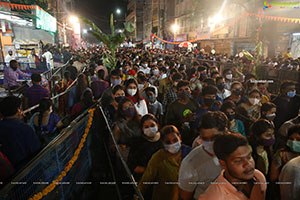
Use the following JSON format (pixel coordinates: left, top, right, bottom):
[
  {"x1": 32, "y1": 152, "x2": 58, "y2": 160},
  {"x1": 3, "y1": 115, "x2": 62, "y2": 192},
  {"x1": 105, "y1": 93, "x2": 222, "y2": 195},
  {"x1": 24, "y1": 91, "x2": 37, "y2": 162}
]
[{"x1": 199, "y1": 169, "x2": 267, "y2": 200}]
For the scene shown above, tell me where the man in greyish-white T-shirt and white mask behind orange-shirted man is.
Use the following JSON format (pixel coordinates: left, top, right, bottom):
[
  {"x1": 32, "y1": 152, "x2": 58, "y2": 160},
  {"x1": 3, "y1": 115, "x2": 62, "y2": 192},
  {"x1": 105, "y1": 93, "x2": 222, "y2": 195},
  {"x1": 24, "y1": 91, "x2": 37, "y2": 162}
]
[{"x1": 179, "y1": 112, "x2": 228, "y2": 200}]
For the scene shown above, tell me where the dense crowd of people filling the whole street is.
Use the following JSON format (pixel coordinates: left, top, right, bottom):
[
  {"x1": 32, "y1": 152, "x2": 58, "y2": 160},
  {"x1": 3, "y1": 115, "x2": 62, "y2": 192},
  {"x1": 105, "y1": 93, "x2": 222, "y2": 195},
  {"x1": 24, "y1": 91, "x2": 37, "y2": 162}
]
[{"x1": 0, "y1": 48, "x2": 300, "y2": 200}]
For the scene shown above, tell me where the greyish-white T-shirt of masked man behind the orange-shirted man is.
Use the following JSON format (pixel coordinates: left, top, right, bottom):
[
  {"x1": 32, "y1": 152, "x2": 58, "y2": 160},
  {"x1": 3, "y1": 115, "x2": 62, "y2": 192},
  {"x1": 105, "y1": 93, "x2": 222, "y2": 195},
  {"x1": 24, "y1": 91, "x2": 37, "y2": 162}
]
[{"x1": 178, "y1": 146, "x2": 222, "y2": 199}]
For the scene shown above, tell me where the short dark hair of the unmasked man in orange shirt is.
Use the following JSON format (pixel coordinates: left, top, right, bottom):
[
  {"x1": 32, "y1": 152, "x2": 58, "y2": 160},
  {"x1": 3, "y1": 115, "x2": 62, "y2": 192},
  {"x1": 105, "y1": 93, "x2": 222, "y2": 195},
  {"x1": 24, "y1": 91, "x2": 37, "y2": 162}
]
[{"x1": 214, "y1": 133, "x2": 249, "y2": 161}]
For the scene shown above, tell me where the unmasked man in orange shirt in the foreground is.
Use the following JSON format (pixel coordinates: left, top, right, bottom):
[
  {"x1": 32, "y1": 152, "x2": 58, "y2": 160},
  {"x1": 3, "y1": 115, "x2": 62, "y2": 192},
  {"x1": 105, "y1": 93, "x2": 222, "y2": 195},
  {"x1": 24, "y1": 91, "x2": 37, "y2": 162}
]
[{"x1": 199, "y1": 133, "x2": 267, "y2": 200}]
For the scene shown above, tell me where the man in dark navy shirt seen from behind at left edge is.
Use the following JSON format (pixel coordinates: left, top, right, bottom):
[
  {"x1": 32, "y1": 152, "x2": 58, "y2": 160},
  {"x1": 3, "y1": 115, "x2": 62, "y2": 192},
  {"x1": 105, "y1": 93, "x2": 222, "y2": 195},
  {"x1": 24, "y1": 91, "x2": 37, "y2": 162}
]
[{"x1": 0, "y1": 96, "x2": 41, "y2": 169}]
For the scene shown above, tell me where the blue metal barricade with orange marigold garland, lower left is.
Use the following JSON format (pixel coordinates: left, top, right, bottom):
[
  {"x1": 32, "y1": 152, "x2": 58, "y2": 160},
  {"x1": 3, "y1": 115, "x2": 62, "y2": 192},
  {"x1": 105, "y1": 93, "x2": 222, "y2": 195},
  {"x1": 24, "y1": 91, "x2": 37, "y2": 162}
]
[{"x1": 0, "y1": 111, "x2": 91, "y2": 200}]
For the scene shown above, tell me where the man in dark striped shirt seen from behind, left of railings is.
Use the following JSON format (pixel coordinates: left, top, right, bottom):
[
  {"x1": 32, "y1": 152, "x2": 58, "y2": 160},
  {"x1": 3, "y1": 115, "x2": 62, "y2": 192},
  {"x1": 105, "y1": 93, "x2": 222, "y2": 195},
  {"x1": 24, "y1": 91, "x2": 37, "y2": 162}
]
[{"x1": 24, "y1": 73, "x2": 50, "y2": 107}]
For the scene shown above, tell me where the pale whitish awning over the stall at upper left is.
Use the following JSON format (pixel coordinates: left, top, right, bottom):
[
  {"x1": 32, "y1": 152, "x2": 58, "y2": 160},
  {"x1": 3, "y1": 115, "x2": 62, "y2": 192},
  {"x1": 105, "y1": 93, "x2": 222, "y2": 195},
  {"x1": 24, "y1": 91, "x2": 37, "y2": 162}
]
[{"x1": 13, "y1": 26, "x2": 54, "y2": 44}]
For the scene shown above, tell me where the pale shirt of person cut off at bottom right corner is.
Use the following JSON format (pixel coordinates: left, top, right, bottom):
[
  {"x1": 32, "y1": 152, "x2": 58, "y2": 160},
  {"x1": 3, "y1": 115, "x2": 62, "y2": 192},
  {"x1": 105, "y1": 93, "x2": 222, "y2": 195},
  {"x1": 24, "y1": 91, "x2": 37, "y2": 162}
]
[{"x1": 279, "y1": 156, "x2": 300, "y2": 200}]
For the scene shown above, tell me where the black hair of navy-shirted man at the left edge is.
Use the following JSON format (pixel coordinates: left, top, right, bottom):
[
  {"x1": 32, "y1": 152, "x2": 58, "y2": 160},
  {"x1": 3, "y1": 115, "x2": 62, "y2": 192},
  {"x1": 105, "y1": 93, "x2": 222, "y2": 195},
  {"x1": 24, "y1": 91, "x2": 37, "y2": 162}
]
[{"x1": 0, "y1": 96, "x2": 22, "y2": 117}]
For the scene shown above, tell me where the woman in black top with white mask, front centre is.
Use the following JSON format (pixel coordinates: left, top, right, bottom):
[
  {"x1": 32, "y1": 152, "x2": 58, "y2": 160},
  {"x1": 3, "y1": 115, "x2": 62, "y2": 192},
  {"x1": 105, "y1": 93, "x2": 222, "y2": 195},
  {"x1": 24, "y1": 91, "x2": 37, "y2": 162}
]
[{"x1": 127, "y1": 114, "x2": 161, "y2": 181}]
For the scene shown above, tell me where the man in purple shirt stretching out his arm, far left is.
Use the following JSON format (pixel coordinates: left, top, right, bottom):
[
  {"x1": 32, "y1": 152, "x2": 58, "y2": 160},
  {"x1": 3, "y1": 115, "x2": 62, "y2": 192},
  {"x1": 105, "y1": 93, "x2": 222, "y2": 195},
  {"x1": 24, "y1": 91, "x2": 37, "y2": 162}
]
[{"x1": 4, "y1": 60, "x2": 30, "y2": 89}]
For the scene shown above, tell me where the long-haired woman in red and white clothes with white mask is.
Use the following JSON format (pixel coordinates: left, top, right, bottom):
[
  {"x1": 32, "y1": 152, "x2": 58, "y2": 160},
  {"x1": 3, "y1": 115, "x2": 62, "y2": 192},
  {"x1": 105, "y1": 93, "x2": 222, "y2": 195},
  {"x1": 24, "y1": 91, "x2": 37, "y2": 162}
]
[{"x1": 125, "y1": 79, "x2": 148, "y2": 116}]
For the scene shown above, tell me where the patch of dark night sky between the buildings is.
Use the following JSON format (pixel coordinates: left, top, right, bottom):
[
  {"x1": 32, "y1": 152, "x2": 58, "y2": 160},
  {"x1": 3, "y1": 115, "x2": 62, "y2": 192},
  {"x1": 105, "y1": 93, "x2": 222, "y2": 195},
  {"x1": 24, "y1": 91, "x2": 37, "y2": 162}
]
[{"x1": 75, "y1": 0, "x2": 127, "y2": 33}]
